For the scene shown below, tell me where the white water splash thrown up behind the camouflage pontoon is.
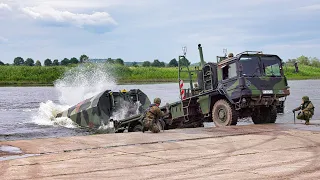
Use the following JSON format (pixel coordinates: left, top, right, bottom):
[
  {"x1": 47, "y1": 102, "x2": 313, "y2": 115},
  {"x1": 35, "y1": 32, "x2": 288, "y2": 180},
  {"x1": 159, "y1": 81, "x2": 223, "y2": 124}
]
[{"x1": 32, "y1": 63, "x2": 116, "y2": 128}]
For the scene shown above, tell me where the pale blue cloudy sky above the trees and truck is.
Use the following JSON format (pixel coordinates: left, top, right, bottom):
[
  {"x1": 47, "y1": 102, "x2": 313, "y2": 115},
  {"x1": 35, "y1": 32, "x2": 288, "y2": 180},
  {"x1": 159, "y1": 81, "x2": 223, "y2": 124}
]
[{"x1": 0, "y1": 0, "x2": 320, "y2": 63}]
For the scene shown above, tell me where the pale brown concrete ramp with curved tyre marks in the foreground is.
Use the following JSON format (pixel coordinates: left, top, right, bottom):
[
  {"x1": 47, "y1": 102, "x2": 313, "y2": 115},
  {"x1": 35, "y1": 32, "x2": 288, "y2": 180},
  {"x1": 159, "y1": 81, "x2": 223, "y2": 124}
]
[{"x1": 0, "y1": 121, "x2": 320, "y2": 179}]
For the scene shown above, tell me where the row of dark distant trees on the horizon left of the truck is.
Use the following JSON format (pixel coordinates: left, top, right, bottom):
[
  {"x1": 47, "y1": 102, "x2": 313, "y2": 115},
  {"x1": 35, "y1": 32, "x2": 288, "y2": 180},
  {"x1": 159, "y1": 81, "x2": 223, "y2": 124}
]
[{"x1": 0, "y1": 54, "x2": 191, "y2": 67}]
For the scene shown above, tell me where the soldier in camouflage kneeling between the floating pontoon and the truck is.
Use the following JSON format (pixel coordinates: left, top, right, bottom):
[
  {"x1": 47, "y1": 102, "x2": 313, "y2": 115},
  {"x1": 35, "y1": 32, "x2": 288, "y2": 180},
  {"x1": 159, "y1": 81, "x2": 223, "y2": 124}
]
[{"x1": 142, "y1": 98, "x2": 165, "y2": 133}]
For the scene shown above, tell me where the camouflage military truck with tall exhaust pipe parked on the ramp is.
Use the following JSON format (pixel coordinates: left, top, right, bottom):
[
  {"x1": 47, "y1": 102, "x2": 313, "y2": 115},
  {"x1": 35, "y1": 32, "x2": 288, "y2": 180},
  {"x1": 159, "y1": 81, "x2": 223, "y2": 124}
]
[{"x1": 160, "y1": 44, "x2": 290, "y2": 129}]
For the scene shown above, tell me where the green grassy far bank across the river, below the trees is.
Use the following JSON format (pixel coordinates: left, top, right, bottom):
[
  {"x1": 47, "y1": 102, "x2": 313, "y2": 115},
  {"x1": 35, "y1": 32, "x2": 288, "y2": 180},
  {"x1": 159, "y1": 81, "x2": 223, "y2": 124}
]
[{"x1": 0, "y1": 65, "x2": 320, "y2": 86}]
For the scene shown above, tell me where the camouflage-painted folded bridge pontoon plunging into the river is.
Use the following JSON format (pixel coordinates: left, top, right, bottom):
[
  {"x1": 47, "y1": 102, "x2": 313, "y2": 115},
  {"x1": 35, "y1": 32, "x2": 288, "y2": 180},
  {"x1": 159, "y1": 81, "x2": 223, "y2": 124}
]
[{"x1": 56, "y1": 89, "x2": 151, "y2": 128}]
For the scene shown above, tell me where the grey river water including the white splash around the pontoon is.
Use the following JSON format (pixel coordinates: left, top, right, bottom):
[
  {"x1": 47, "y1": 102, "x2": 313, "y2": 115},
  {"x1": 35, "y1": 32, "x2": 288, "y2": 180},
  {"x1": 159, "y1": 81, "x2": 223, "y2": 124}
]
[{"x1": 0, "y1": 79, "x2": 320, "y2": 141}]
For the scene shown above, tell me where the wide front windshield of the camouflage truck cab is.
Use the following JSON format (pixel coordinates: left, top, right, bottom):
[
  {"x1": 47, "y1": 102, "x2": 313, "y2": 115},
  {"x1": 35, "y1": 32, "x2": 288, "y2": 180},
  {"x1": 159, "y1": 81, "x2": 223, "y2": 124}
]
[{"x1": 239, "y1": 56, "x2": 281, "y2": 77}]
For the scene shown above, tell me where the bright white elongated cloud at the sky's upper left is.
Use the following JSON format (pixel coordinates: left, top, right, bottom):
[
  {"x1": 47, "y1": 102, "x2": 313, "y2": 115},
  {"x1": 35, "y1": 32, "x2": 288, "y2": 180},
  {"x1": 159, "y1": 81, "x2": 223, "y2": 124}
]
[{"x1": 21, "y1": 6, "x2": 117, "y2": 33}]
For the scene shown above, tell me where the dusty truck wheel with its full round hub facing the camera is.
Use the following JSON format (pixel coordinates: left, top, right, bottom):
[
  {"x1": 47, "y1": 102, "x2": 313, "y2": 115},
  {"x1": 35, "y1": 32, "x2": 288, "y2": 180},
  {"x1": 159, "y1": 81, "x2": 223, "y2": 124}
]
[{"x1": 212, "y1": 99, "x2": 239, "y2": 127}]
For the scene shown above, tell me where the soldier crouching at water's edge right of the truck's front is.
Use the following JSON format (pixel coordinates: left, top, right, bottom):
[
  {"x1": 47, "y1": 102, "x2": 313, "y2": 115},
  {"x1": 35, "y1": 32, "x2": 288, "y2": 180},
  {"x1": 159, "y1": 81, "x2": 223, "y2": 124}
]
[{"x1": 292, "y1": 96, "x2": 314, "y2": 125}]
